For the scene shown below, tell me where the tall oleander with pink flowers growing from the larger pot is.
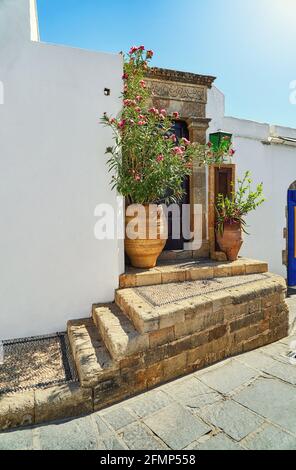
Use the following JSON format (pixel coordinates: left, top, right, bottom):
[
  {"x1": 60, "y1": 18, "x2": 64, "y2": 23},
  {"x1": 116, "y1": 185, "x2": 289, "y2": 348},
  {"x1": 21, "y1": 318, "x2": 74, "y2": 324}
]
[{"x1": 102, "y1": 46, "x2": 205, "y2": 204}]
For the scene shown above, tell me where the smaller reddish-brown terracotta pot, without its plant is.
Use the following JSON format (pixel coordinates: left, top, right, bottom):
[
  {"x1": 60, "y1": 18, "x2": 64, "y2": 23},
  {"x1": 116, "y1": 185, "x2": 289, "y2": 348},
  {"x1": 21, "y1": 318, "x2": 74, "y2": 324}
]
[{"x1": 217, "y1": 223, "x2": 243, "y2": 261}]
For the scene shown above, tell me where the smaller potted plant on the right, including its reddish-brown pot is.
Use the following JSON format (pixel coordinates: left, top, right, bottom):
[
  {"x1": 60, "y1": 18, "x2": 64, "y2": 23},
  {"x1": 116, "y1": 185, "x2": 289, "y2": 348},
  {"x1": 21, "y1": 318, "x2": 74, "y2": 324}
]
[{"x1": 216, "y1": 171, "x2": 265, "y2": 261}]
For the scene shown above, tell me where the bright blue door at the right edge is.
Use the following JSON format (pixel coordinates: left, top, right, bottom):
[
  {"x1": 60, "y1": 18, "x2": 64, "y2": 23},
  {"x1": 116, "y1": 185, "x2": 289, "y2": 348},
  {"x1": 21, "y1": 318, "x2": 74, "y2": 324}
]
[{"x1": 288, "y1": 190, "x2": 296, "y2": 287}]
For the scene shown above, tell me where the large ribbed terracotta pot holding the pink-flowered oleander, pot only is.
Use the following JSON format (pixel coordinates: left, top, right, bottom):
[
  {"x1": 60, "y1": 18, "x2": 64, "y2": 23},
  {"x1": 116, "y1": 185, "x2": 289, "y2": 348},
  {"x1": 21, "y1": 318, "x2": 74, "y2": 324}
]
[{"x1": 125, "y1": 204, "x2": 167, "y2": 269}]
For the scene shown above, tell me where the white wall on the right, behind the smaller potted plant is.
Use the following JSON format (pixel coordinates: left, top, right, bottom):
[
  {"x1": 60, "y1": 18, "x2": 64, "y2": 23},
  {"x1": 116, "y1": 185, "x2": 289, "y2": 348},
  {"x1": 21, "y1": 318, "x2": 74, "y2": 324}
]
[{"x1": 207, "y1": 86, "x2": 296, "y2": 277}]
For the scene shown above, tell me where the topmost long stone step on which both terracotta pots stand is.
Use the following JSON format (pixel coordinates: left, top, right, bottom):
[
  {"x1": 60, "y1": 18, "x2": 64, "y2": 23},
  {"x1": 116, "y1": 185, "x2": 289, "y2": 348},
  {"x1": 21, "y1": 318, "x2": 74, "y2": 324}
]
[{"x1": 119, "y1": 258, "x2": 268, "y2": 289}]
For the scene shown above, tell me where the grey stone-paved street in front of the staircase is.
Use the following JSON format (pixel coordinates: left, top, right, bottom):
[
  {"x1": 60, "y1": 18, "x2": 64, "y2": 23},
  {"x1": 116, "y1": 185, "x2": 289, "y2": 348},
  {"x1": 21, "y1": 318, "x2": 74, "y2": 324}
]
[{"x1": 0, "y1": 318, "x2": 296, "y2": 450}]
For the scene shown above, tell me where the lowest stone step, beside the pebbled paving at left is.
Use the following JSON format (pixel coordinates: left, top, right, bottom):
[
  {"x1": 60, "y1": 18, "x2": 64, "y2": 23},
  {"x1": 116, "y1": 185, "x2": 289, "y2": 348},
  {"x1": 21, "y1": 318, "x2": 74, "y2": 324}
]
[{"x1": 68, "y1": 319, "x2": 119, "y2": 387}]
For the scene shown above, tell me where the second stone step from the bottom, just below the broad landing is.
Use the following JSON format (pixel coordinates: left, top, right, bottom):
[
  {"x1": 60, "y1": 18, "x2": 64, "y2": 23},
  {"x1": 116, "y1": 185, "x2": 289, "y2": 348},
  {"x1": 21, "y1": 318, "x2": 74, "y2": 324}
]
[{"x1": 92, "y1": 303, "x2": 149, "y2": 361}]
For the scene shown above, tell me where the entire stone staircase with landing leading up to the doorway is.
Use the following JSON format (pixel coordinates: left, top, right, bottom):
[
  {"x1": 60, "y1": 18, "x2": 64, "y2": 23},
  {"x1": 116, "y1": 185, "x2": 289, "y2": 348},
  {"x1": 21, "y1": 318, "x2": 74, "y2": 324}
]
[{"x1": 68, "y1": 259, "x2": 289, "y2": 410}]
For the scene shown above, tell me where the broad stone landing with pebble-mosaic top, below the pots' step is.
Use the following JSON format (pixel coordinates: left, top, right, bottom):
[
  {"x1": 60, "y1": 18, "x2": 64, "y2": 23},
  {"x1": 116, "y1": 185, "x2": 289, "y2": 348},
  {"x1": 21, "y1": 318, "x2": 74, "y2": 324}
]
[{"x1": 115, "y1": 273, "x2": 286, "y2": 337}]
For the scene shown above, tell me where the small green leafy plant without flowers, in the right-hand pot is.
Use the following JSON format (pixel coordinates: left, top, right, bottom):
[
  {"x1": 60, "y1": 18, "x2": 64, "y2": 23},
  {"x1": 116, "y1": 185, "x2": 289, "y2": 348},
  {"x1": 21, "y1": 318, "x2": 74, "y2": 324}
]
[{"x1": 216, "y1": 171, "x2": 265, "y2": 235}]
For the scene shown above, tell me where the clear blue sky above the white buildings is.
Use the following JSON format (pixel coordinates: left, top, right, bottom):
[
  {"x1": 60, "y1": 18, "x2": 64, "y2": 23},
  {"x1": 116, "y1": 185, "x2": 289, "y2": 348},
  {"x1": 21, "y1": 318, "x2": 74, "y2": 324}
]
[{"x1": 37, "y1": 0, "x2": 296, "y2": 127}]
